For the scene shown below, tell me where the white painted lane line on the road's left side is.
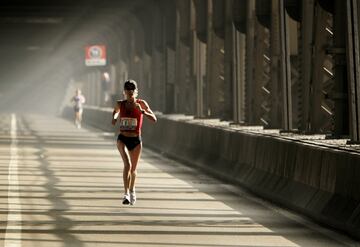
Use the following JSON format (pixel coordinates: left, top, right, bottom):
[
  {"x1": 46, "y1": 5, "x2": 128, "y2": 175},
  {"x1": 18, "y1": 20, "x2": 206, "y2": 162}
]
[{"x1": 4, "y1": 114, "x2": 21, "y2": 247}]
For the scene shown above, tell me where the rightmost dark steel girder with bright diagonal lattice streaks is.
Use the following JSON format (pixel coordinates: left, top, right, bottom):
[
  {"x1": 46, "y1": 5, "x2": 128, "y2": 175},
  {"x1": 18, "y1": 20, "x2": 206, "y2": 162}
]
[{"x1": 303, "y1": 5, "x2": 334, "y2": 132}]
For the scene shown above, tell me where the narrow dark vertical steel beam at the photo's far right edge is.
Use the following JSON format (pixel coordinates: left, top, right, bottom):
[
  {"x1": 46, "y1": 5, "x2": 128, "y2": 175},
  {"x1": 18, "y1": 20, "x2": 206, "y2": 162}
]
[{"x1": 346, "y1": 0, "x2": 360, "y2": 142}]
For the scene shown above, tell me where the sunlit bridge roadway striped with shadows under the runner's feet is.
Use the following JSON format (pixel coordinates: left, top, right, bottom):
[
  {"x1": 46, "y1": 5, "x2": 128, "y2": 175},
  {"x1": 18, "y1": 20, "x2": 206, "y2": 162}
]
[{"x1": 0, "y1": 114, "x2": 360, "y2": 247}]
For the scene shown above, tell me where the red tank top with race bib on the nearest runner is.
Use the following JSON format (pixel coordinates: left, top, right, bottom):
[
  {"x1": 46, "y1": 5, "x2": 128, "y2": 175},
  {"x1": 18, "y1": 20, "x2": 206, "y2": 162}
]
[{"x1": 118, "y1": 99, "x2": 143, "y2": 135}]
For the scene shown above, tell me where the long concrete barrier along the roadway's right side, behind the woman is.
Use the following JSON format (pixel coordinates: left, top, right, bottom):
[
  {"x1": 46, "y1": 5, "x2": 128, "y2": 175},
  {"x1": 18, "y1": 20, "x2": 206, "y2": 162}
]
[{"x1": 64, "y1": 108, "x2": 360, "y2": 238}]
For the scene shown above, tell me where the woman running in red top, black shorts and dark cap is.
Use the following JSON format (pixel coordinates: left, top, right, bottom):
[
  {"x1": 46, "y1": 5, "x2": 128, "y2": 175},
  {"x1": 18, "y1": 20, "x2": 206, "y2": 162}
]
[{"x1": 112, "y1": 80, "x2": 157, "y2": 205}]
